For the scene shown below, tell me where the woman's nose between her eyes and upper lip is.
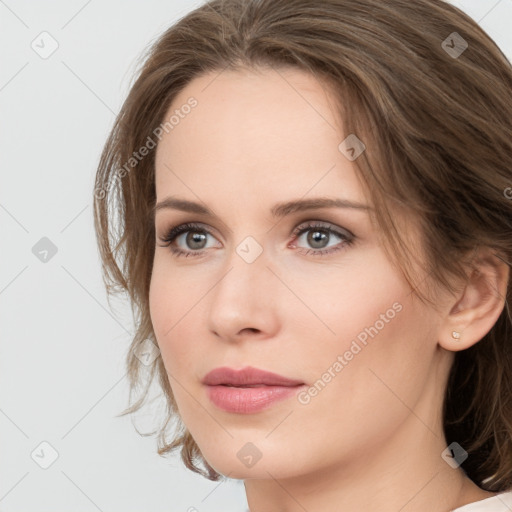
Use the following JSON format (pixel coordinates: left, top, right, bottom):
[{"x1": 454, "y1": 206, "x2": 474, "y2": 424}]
[{"x1": 208, "y1": 243, "x2": 283, "y2": 342}]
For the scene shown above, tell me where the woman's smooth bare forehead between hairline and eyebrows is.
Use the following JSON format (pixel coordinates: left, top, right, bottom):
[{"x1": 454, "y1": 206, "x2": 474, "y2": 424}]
[{"x1": 156, "y1": 68, "x2": 364, "y2": 206}]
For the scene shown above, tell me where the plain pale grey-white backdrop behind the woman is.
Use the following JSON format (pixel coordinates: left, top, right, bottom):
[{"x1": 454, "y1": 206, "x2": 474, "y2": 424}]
[{"x1": 0, "y1": 0, "x2": 512, "y2": 512}]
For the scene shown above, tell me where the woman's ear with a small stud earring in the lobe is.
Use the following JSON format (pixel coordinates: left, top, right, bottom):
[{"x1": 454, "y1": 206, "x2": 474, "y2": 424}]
[{"x1": 438, "y1": 248, "x2": 510, "y2": 351}]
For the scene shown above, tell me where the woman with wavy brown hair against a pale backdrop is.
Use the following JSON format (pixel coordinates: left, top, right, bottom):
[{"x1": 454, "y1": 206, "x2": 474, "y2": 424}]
[{"x1": 95, "y1": 0, "x2": 512, "y2": 512}]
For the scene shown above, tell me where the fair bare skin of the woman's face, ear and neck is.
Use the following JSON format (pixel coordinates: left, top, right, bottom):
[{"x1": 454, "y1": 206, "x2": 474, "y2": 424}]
[{"x1": 150, "y1": 68, "x2": 508, "y2": 512}]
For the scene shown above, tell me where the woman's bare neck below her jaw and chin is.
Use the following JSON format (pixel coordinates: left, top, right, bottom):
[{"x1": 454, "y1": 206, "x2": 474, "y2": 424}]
[{"x1": 244, "y1": 400, "x2": 492, "y2": 512}]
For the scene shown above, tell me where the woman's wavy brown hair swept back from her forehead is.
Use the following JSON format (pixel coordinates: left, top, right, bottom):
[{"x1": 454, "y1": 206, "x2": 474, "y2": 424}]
[{"x1": 94, "y1": 0, "x2": 512, "y2": 491}]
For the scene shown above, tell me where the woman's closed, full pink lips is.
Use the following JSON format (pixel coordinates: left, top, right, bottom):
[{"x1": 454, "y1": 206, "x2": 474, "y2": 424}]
[{"x1": 202, "y1": 367, "x2": 305, "y2": 413}]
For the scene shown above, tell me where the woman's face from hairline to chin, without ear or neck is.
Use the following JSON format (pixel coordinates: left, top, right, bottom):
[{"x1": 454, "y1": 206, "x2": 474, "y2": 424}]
[{"x1": 150, "y1": 69, "x2": 451, "y2": 478}]
